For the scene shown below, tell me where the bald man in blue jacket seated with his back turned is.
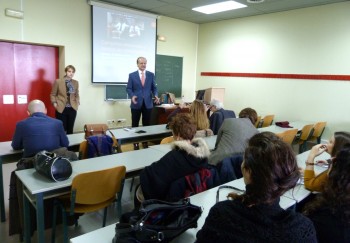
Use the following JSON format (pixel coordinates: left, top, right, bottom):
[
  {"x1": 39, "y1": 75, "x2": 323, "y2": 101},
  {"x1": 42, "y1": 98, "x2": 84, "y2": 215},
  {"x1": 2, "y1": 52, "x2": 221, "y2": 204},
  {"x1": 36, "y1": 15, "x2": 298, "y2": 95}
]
[{"x1": 11, "y1": 100, "x2": 69, "y2": 158}]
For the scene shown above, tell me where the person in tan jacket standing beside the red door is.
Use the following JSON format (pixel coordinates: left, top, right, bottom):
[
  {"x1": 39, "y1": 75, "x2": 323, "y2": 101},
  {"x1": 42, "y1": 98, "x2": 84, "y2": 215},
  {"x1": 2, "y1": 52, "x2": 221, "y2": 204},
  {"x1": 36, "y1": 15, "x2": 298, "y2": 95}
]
[{"x1": 50, "y1": 65, "x2": 80, "y2": 134}]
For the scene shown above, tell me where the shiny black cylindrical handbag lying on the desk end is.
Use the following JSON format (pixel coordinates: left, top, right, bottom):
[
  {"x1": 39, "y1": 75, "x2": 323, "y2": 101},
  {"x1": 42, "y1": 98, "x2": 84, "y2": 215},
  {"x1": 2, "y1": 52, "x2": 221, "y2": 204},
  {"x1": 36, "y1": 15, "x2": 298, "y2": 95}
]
[{"x1": 34, "y1": 150, "x2": 73, "y2": 181}]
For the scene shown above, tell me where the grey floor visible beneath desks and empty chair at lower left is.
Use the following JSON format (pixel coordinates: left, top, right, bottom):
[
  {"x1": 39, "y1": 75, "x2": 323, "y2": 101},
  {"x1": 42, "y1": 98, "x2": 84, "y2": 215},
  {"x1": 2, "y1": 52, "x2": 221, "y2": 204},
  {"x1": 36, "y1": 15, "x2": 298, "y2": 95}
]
[{"x1": 0, "y1": 144, "x2": 139, "y2": 243}]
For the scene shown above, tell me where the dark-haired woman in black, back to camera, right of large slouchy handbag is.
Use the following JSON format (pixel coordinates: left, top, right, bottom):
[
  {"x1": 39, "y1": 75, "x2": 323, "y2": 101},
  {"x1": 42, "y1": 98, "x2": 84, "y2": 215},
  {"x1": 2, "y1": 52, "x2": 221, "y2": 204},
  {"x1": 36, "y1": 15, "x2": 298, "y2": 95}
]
[{"x1": 196, "y1": 132, "x2": 317, "y2": 243}]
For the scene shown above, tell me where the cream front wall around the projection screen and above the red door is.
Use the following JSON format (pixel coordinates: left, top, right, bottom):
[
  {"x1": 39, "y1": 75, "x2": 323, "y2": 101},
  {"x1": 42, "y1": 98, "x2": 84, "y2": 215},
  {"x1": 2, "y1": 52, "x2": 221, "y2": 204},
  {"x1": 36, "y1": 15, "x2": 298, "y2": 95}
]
[{"x1": 0, "y1": 0, "x2": 198, "y2": 131}]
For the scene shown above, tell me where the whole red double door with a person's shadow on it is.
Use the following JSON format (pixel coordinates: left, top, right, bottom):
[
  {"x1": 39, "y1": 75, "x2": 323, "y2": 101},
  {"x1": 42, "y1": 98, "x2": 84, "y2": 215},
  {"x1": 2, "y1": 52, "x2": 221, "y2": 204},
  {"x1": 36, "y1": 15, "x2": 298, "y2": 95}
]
[{"x1": 0, "y1": 42, "x2": 58, "y2": 141}]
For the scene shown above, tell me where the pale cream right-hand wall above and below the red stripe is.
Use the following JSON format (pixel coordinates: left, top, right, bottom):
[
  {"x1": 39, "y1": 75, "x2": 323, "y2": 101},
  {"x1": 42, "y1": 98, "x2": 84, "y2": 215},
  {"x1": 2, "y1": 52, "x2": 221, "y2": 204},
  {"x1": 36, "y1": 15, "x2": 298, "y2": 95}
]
[{"x1": 197, "y1": 2, "x2": 350, "y2": 138}]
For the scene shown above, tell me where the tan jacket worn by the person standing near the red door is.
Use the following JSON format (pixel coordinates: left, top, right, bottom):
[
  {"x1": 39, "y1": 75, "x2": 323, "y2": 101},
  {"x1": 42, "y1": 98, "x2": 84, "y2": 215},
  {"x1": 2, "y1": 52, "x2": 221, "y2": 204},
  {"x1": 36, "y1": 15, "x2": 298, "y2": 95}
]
[{"x1": 50, "y1": 78, "x2": 80, "y2": 113}]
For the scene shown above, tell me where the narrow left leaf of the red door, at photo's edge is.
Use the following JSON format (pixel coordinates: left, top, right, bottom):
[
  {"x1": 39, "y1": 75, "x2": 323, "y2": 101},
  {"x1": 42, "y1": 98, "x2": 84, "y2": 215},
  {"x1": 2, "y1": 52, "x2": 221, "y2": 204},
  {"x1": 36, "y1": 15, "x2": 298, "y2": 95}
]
[{"x1": 0, "y1": 42, "x2": 17, "y2": 141}]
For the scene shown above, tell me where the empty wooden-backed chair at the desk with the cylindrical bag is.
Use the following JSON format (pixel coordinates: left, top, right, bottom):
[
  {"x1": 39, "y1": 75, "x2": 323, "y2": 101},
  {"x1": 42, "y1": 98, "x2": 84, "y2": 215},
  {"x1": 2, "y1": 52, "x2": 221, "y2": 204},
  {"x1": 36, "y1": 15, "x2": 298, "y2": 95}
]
[{"x1": 51, "y1": 166, "x2": 126, "y2": 242}]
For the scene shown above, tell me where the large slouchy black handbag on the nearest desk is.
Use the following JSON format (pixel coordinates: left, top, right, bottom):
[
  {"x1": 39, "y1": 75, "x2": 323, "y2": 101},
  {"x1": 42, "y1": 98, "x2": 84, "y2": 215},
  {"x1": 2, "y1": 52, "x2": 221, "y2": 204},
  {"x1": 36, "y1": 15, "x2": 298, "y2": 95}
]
[{"x1": 112, "y1": 198, "x2": 202, "y2": 243}]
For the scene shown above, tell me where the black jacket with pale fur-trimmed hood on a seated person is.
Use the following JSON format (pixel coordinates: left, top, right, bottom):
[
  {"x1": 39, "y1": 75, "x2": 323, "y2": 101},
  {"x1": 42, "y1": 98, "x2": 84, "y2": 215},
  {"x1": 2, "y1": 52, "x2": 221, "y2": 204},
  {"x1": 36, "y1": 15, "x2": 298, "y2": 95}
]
[{"x1": 140, "y1": 138, "x2": 210, "y2": 200}]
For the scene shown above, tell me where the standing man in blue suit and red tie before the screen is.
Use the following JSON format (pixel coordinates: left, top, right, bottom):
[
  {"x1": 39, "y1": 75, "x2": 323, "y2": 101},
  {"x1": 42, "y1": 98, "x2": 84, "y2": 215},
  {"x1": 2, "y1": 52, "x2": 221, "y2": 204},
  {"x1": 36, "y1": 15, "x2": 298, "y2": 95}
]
[{"x1": 126, "y1": 57, "x2": 159, "y2": 149}]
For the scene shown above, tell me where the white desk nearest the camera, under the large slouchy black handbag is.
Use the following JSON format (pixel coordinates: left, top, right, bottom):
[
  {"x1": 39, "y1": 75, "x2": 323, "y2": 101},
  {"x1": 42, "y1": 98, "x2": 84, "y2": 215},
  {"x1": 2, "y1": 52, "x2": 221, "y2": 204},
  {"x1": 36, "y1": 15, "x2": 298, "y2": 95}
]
[{"x1": 70, "y1": 178, "x2": 296, "y2": 243}]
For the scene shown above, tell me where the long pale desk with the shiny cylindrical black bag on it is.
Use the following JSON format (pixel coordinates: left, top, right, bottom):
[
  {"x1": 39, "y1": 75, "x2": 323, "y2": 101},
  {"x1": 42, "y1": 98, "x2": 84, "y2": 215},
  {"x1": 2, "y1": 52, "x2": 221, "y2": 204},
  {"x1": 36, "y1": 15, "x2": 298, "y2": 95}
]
[{"x1": 16, "y1": 149, "x2": 168, "y2": 242}]
